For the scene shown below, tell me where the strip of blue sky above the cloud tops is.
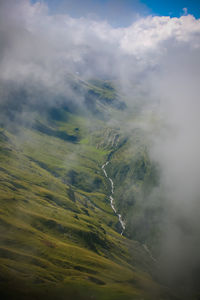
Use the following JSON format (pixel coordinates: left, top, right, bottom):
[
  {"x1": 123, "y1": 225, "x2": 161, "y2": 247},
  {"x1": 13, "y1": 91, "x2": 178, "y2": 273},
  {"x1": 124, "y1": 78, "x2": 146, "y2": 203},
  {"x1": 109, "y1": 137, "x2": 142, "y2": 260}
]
[{"x1": 32, "y1": 0, "x2": 200, "y2": 26}]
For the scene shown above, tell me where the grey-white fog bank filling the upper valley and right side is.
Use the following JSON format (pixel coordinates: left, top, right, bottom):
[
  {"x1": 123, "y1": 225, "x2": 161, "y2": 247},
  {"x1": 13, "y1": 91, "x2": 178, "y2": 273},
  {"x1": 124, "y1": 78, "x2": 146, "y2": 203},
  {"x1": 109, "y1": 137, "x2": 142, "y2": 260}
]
[{"x1": 0, "y1": 0, "x2": 200, "y2": 296}]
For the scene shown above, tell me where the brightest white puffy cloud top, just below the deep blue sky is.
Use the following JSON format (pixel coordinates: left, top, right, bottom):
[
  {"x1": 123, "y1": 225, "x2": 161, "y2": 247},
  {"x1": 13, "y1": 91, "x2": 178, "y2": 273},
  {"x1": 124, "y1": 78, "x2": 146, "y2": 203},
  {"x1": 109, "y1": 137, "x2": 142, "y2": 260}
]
[{"x1": 120, "y1": 15, "x2": 200, "y2": 56}]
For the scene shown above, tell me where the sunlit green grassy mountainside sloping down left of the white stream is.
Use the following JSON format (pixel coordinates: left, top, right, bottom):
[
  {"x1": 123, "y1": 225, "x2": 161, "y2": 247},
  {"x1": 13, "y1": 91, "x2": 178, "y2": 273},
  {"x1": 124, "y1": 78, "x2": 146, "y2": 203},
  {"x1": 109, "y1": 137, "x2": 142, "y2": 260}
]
[{"x1": 0, "y1": 81, "x2": 175, "y2": 300}]
